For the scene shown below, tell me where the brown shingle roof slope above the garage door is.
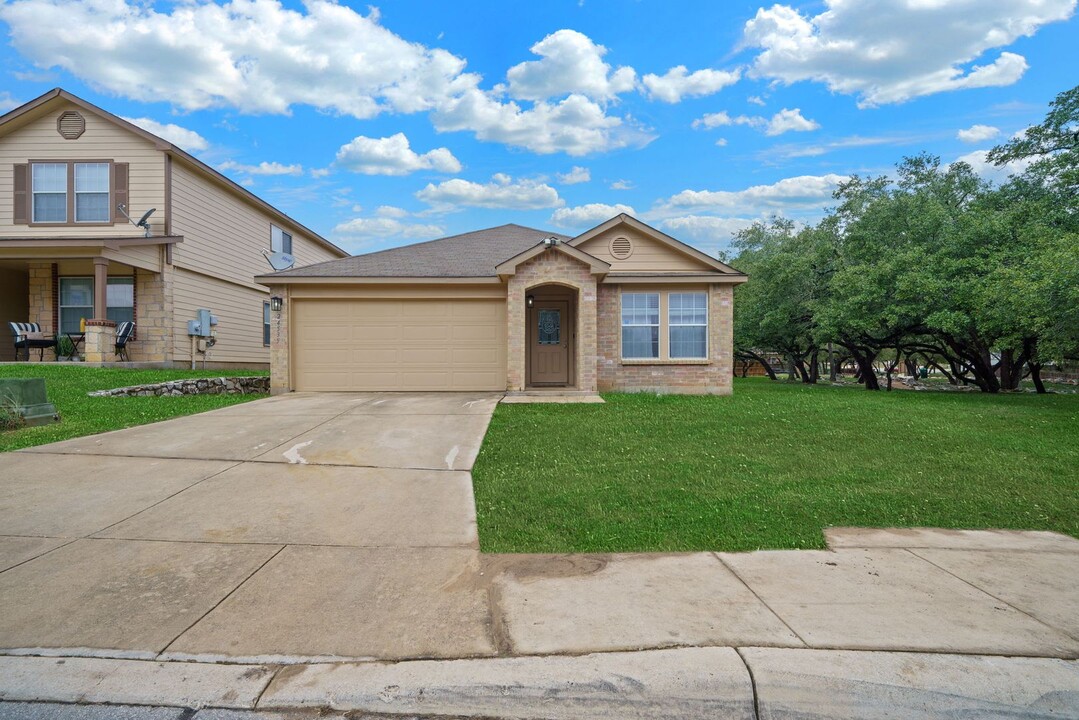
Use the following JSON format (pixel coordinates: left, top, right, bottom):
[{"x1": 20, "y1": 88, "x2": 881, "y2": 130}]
[{"x1": 271, "y1": 223, "x2": 570, "y2": 277}]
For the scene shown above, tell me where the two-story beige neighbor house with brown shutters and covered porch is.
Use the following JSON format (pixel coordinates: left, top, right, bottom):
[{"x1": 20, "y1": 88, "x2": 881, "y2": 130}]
[{"x1": 0, "y1": 89, "x2": 347, "y2": 367}]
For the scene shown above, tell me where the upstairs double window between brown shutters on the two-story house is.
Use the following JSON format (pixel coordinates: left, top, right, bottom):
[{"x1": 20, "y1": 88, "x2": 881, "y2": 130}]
[{"x1": 30, "y1": 162, "x2": 112, "y2": 223}]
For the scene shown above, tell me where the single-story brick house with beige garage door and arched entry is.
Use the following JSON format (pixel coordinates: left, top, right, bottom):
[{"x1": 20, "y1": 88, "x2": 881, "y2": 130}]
[{"x1": 256, "y1": 215, "x2": 747, "y2": 394}]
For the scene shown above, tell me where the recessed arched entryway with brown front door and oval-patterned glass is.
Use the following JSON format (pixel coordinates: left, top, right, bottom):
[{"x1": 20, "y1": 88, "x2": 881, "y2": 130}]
[{"x1": 524, "y1": 284, "x2": 577, "y2": 388}]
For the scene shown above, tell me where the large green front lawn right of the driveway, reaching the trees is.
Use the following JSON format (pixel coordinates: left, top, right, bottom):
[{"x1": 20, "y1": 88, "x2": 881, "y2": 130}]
[{"x1": 473, "y1": 379, "x2": 1079, "y2": 553}]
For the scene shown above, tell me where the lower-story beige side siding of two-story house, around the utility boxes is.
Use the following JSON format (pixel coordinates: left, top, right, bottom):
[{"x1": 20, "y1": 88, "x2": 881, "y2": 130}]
[{"x1": 172, "y1": 268, "x2": 270, "y2": 364}]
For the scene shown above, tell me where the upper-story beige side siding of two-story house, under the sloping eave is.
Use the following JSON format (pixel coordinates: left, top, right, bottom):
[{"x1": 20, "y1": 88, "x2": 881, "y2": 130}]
[{"x1": 172, "y1": 160, "x2": 339, "y2": 290}]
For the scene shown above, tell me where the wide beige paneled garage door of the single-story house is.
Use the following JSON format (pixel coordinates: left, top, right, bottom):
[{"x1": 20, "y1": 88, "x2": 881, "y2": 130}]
[{"x1": 290, "y1": 299, "x2": 506, "y2": 391}]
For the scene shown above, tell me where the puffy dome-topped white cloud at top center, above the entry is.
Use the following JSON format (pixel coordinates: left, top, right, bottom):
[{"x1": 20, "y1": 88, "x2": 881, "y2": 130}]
[{"x1": 506, "y1": 29, "x2": 637, "y2": 100}]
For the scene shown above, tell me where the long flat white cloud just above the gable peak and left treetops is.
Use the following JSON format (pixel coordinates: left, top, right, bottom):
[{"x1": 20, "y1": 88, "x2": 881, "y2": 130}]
[{"x1": 656, "y1": 174, "x2": 847, "y2": 217}]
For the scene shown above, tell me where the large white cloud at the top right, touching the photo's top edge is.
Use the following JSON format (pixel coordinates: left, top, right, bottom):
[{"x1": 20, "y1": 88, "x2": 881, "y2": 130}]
[{"x1": 742, "y1": 0, "x2": 1076, "y2": 107}]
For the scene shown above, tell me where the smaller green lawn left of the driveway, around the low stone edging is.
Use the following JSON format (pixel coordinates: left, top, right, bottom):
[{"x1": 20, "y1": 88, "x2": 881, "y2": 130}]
[{"x1": 0, "y1": 363, "x2": 267, "y2": 451}]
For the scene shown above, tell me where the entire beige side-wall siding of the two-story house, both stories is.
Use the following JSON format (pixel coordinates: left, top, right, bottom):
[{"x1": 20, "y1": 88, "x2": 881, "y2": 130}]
[{"x1": 170, "y1": 161, "x2": 339, "y2": 365}]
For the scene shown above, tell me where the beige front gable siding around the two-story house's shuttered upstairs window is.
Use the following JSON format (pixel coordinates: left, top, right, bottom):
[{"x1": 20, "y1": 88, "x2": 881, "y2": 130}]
[{"x1": 0, "y1": 103, "x2": 165, "y2": 237}]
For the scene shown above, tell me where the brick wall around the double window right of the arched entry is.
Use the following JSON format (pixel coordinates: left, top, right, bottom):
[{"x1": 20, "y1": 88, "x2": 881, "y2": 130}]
[{"x1": 598, "y1": 284, "x2": 734, "y2": 395}]
